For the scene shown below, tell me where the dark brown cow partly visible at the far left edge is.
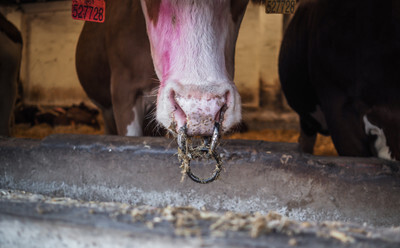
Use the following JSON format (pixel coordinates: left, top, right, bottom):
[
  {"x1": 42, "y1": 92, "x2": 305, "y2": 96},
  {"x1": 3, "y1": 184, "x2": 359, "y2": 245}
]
[{"x1": 0, "y1": 13, "x2": 22, "y2": 136}]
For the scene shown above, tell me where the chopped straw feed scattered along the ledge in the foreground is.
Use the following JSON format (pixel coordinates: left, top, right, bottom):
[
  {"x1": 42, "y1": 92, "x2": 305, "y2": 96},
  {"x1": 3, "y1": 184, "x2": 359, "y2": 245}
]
[{"x1": 0, "y1": 189, "x2": 388, "y2": 246}]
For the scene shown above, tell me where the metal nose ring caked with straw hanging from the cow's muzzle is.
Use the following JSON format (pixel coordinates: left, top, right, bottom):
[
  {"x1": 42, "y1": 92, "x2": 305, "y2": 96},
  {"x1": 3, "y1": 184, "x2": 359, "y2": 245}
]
[{"x1": 177, "y1": 106, "x2": 226, "y2": 184}]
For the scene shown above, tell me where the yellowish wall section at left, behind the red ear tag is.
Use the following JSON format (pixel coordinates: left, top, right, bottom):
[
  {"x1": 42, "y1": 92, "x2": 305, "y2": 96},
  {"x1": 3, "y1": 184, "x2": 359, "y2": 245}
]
[{"x1": 3, "y1": 1, "x2": 86, "y2": 105}]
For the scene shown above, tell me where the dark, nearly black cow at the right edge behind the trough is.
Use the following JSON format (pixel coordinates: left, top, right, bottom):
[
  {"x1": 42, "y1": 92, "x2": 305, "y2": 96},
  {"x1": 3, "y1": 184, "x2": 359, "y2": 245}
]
[{"x1": 279, "y1": 0, "x2": 400, "y2": 160}]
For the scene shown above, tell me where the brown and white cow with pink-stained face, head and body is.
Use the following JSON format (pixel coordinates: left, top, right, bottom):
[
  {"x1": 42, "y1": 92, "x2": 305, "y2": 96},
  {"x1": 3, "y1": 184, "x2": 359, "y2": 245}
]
[{"x1": 76, "y1": 0, "x2": 268, "y2": 136}]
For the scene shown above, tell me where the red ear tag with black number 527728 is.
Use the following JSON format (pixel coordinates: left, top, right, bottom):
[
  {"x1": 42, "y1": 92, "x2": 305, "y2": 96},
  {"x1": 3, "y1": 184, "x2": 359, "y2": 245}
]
[{"x1": 72, "y1": 0, "x2": 106, "y2": 22}]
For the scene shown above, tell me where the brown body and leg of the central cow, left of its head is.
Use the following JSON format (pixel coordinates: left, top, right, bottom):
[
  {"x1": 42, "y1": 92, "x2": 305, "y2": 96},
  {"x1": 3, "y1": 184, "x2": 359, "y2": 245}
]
[{"x1": 76, "y1": 1, "x2": 157, "y2": 136}]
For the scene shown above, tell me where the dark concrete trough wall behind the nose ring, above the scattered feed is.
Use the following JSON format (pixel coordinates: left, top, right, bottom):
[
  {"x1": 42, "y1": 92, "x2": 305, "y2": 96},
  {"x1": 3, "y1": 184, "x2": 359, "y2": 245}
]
[{"x1": 0, "y1": 135, "x2": 400, "y2": 226}]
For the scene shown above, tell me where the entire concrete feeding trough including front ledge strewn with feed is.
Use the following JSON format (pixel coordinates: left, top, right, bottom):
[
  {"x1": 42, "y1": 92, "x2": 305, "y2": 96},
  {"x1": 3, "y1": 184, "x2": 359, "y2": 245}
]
[{"x1": 0, "y1": 135, "x2": 400, "y2": 247}]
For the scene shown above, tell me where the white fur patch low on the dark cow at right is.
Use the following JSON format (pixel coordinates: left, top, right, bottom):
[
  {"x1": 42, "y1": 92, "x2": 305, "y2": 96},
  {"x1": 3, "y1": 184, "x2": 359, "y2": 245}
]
[{"x1": 363, "y1": 115, "x2": 394, "y2": 160}]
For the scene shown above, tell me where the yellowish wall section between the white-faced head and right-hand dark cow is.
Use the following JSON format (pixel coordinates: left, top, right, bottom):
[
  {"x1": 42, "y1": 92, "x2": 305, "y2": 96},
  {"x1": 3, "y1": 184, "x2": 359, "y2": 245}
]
[{"x1": 235, "y1": 4, "x2": 283, "y2": 107}]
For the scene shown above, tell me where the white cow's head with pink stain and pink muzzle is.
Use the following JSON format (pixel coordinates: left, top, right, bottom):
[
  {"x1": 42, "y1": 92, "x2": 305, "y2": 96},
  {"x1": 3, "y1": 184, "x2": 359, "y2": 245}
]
[{"x1": 141, "y1": 0, "x2": 252, "y2": 136}]
